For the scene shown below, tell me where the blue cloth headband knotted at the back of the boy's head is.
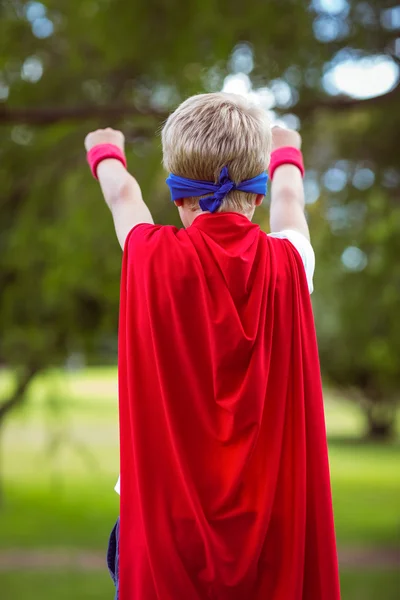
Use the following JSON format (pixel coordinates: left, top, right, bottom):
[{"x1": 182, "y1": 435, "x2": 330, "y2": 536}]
[{"x1": 167, "y1": 166, "x2": 268, "y2": 213}]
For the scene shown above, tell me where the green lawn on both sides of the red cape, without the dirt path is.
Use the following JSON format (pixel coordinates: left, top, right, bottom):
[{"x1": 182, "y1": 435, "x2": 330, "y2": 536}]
[{"x1": 0, "y1": 369, "x2": 400, "y2": 600}]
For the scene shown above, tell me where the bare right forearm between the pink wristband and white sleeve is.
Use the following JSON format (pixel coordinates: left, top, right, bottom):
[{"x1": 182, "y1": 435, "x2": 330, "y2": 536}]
[{"x1": 270, "y1": 164, "x2": 310, "y2": 239}]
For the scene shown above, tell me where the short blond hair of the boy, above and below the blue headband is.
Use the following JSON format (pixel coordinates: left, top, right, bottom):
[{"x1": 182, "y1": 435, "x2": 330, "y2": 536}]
[{"x1": 162, "y1": 92, "x2": 272, "y2": 212}]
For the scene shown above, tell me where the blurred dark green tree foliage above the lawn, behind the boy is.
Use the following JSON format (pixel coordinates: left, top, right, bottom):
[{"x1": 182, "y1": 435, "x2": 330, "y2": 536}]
[{"x1": 0, "y1": 0, "x2": 400, "y2": 434}]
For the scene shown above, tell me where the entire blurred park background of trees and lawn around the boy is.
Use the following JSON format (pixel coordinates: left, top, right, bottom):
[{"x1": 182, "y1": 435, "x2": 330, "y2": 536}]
[{"x1": 0, "y1": 0, "x2": 400, "y2": 600}]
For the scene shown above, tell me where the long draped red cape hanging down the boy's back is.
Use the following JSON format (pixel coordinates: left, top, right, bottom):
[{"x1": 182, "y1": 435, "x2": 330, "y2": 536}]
[{"x1": 119, "y1": 213, "x2": 340, "y2": 600}]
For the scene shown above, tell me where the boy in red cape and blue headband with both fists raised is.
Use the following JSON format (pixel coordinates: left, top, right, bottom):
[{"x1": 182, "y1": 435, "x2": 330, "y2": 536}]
[{"x1": 85, "y1": 93, "x2": 339, "y2": 600}]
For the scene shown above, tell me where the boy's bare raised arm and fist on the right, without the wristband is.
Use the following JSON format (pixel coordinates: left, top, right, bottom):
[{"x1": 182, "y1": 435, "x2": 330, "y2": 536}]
[{"x1": 270, "y1": 127, "x2": 310, "y2": 239}]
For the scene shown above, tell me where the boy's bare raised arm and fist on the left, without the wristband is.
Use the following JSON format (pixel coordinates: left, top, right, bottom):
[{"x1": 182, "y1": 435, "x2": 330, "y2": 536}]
[{"x1": 85, "y1": 129, "x2": 153, "y2": 249}]
